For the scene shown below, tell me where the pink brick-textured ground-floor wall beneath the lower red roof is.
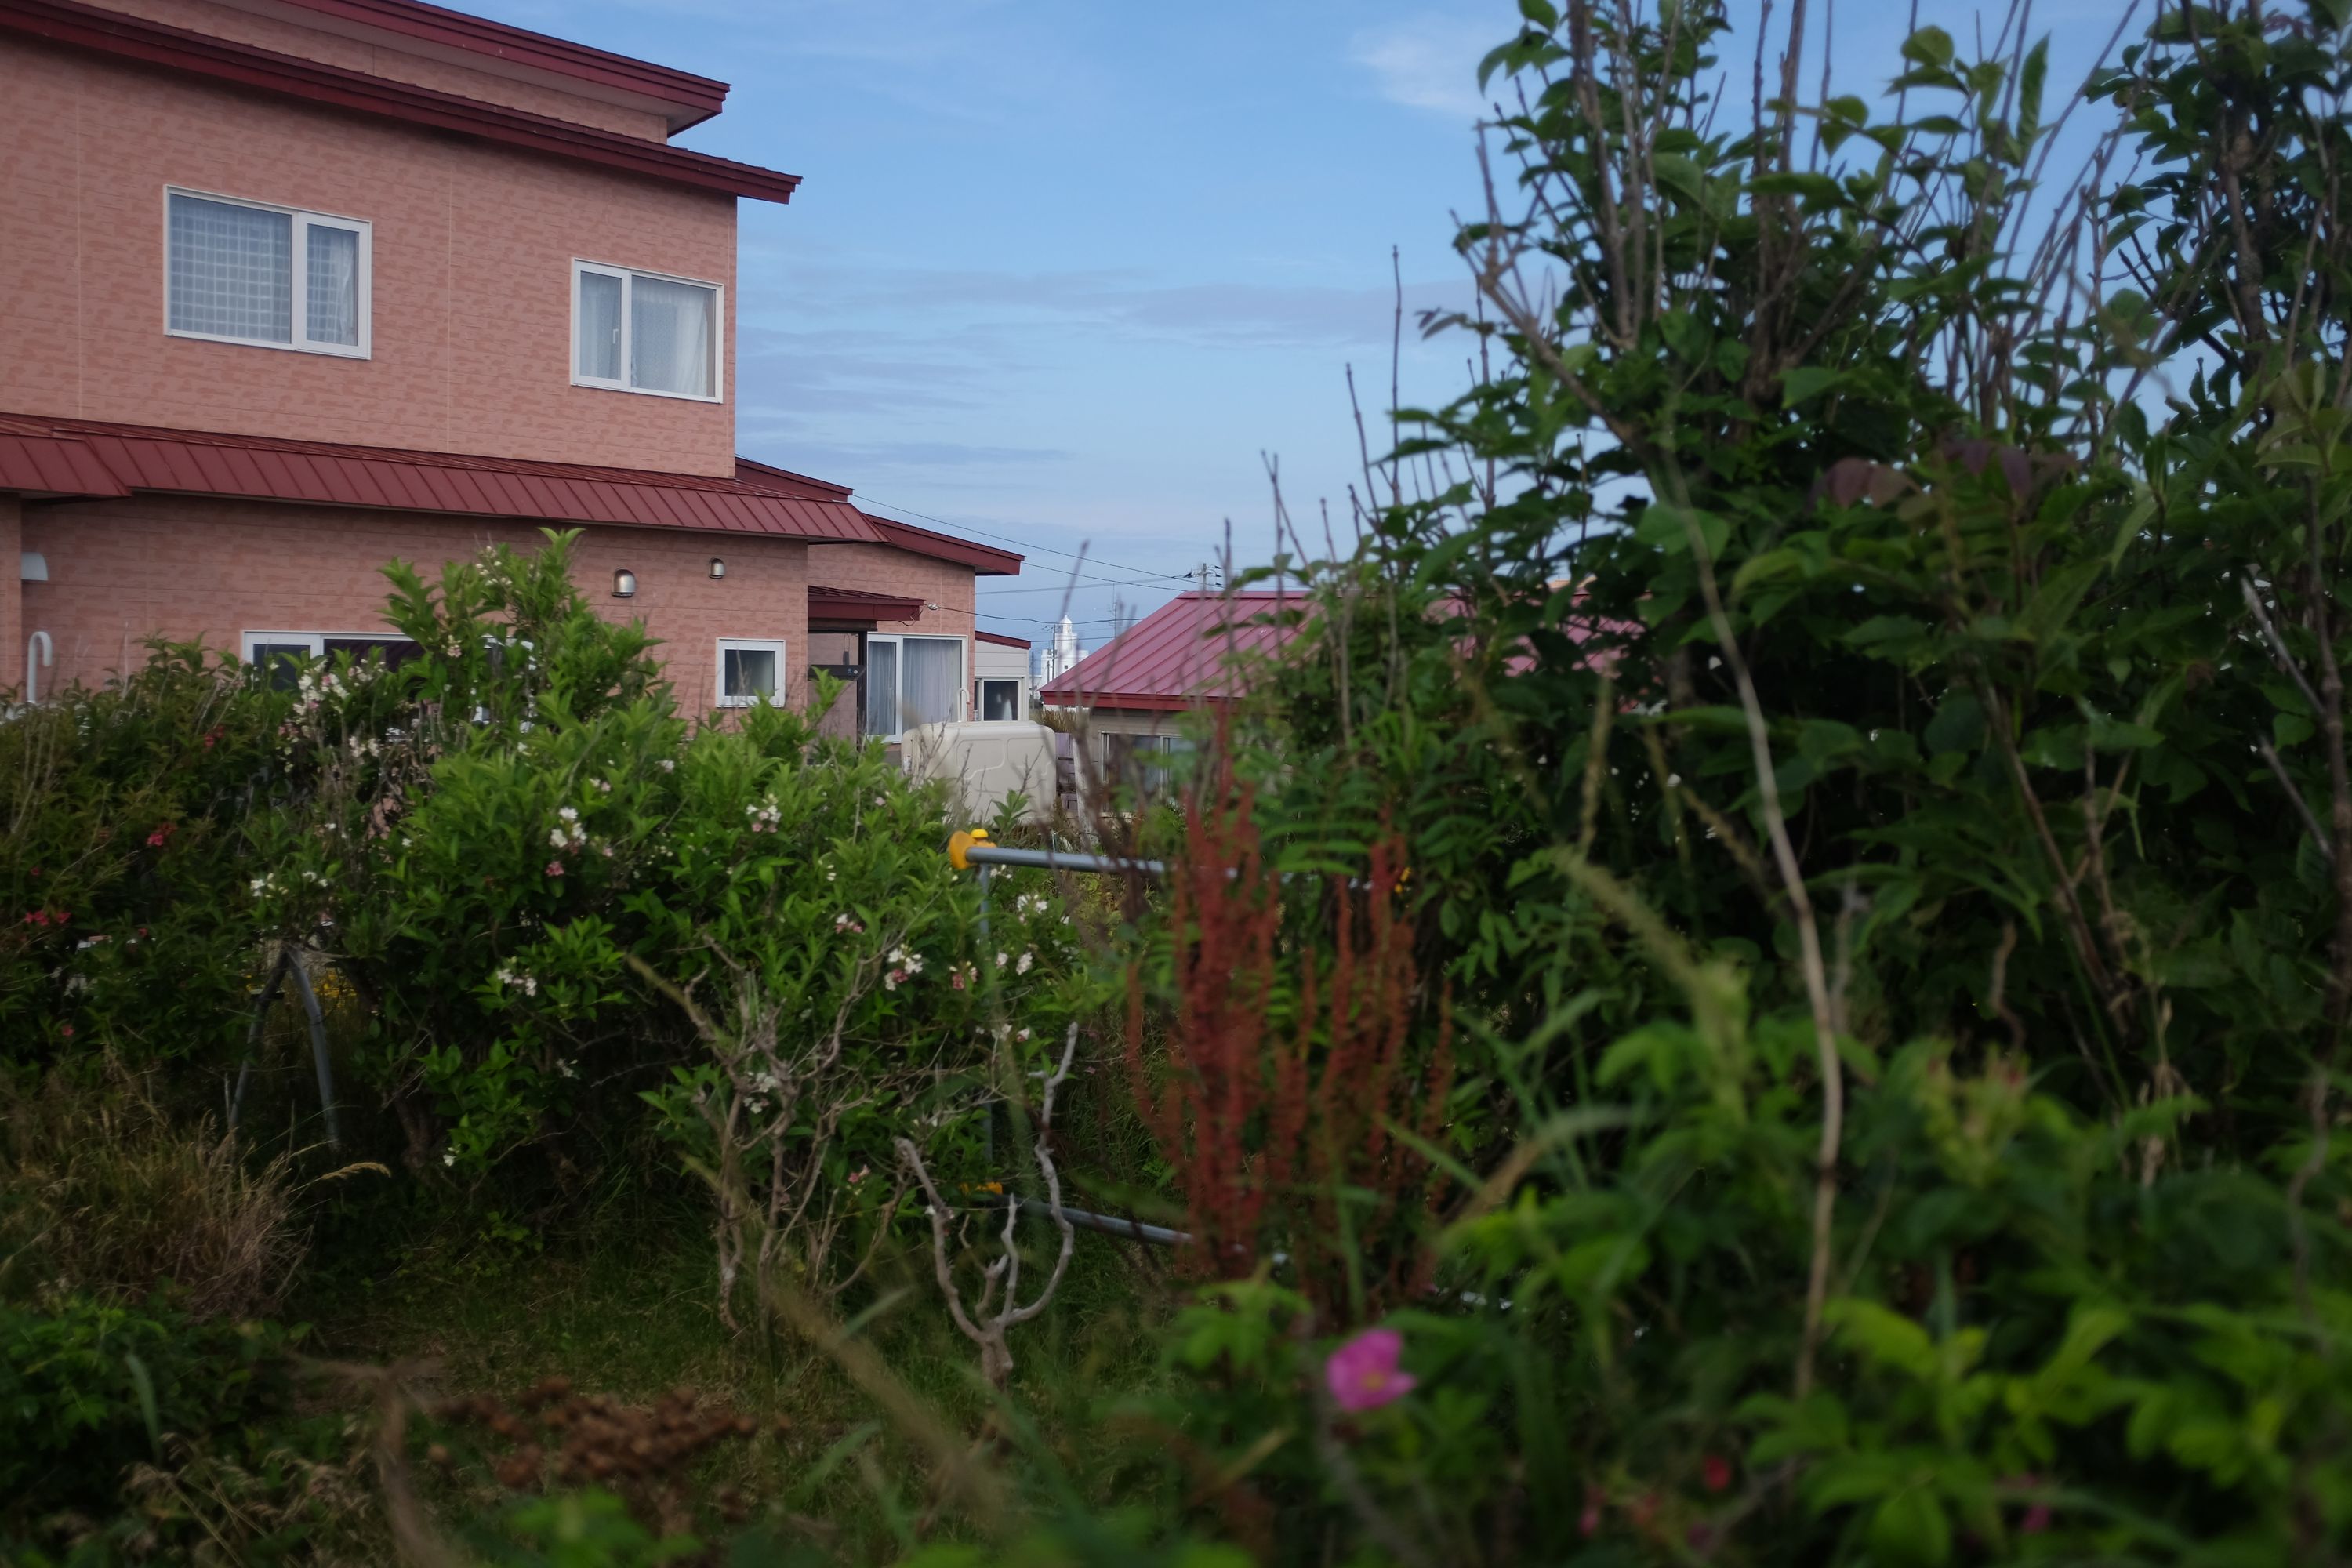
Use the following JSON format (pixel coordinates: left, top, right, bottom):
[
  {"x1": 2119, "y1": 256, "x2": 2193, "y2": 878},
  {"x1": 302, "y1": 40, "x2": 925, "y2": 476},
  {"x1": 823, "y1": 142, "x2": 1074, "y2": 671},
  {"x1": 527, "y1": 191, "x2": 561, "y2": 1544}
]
[{"x1": 9, "y1": 496, "x2": 809, "y2": 715}]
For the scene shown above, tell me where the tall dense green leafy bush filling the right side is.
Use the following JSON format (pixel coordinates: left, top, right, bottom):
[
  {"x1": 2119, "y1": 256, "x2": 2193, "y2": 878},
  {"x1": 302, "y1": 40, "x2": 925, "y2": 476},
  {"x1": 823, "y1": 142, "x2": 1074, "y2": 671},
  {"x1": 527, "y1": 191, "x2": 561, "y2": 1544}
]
[{"x1": 1087, "y1": 0, "x2": 2352, "y2": 1563}]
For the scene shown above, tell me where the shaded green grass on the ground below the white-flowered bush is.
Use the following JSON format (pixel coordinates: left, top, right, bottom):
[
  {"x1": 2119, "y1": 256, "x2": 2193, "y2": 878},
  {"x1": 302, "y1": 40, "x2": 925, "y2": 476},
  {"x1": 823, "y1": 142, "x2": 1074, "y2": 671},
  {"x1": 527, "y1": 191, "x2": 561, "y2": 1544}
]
[{"x1": 292, "y1": 1210, "x2": 1169, "y2": 1561}]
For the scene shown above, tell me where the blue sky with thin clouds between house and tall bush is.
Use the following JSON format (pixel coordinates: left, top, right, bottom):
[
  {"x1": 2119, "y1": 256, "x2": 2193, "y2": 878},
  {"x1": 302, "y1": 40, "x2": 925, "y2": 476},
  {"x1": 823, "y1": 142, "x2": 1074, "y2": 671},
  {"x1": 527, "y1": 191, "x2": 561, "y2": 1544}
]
[{"x1": 473, "y1": 0, "x2": 2124, "y2": 644}]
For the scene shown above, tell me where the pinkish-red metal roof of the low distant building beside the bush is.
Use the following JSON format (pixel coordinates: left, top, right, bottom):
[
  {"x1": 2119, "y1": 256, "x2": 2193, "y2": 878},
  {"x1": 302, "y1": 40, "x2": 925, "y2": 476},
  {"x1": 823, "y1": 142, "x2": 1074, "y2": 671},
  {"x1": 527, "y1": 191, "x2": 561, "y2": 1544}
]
[{"x1": 1037, "y1": 588, "x2": 1308, "y2": 710}]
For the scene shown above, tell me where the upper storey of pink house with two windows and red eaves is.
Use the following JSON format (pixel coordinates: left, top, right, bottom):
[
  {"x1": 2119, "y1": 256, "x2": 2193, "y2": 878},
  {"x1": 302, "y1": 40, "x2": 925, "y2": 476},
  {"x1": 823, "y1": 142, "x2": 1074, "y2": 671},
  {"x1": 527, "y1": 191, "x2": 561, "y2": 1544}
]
[{"x1": 0, "y1": 0, "x2": 797, "y2": 477}]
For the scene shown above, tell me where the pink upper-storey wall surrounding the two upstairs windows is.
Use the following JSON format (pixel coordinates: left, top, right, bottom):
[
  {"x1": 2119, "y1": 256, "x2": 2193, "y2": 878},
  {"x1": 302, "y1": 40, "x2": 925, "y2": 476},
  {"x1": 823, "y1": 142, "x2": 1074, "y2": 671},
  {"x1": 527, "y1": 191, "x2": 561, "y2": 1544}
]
[{"x1": 0, "y1": 40, "x2": 736, "y2": 475}]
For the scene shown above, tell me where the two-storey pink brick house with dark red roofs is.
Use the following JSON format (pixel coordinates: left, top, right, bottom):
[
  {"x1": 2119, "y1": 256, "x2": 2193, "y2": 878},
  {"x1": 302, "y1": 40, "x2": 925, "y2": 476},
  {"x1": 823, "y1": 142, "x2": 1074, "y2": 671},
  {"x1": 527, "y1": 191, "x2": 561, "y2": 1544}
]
[{"x1": 0, "y1": 0, "x2": 1021, "y2": 734}]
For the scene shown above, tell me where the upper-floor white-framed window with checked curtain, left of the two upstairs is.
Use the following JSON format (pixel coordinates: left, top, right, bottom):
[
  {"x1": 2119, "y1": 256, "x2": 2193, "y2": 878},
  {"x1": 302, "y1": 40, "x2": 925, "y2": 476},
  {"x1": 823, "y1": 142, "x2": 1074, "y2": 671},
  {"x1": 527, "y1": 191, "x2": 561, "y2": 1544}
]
[{"x1": 162, "y1": 186, "x2": 374, "y2": 360}]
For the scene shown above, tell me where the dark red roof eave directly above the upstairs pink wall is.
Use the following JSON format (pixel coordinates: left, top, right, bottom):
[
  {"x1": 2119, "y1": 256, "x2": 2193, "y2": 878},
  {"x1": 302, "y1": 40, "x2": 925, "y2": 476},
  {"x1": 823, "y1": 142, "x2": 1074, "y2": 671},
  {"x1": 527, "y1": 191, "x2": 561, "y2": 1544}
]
[{"x1": 0, "y1": 0, "x2": 800, "y2": 202}]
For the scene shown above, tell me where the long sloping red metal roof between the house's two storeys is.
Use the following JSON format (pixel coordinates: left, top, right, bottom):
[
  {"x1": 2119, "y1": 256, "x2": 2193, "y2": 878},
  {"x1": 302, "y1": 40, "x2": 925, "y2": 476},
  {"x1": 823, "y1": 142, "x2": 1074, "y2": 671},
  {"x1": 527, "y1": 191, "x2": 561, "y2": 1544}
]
[{"x1": 0, "y1": 416, "x2": 882, "y2": 543}]
